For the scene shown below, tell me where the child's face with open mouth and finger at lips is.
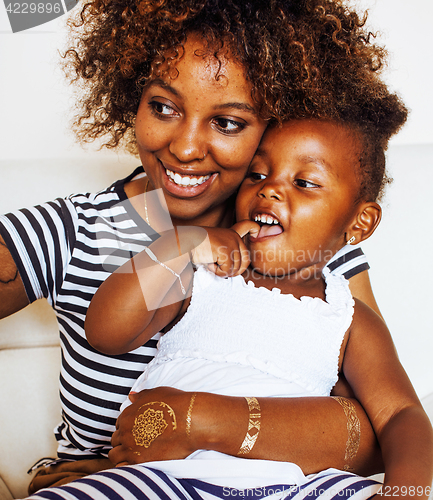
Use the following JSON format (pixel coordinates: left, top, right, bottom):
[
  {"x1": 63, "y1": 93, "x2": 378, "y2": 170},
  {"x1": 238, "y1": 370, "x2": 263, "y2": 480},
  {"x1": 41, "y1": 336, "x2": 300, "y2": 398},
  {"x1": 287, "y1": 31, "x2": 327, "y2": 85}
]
[{"x1": 236, "y1": 120, "x2": 359, "y2": 276}]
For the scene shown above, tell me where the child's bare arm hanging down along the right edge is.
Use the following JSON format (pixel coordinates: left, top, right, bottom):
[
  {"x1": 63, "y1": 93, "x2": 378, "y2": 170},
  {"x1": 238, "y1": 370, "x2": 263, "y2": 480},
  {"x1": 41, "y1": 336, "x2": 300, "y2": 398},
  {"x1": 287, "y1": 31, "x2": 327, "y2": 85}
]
[{"x1": 343, "y1": 301, "x2": 433, "y2": 498}]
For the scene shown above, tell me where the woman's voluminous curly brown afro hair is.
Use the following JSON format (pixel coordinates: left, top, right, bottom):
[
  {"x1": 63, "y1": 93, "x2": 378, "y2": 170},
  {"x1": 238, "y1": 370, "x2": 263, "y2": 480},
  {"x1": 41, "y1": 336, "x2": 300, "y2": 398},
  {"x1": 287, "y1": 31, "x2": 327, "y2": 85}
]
[{"x1": 64, "y1": 0, "x2": 406, "y2": 202}]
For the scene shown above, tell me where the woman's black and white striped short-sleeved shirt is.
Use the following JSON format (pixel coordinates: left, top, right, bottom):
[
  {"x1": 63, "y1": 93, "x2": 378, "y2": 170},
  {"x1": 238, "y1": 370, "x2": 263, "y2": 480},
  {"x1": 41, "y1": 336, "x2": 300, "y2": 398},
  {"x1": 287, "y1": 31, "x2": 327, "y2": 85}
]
[{"x1": 0, "y1": 167, "x2": 368, "y2": 459}]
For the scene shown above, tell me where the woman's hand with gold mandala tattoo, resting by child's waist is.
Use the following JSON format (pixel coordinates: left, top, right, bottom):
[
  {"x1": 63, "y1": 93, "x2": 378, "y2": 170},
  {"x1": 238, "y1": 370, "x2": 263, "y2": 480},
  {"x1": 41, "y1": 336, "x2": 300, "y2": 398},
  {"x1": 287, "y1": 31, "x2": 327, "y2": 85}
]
[{"x1": 109, "y1": 387, "x2": 196, "y2": 466}]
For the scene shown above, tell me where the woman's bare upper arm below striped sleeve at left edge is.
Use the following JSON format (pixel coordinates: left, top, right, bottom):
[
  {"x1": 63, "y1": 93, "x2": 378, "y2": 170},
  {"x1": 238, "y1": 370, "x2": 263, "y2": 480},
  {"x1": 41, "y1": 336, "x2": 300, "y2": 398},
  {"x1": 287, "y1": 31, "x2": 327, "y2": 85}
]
[{"x1": 0, "y1": 236, "x2": 29, "y2": 318}]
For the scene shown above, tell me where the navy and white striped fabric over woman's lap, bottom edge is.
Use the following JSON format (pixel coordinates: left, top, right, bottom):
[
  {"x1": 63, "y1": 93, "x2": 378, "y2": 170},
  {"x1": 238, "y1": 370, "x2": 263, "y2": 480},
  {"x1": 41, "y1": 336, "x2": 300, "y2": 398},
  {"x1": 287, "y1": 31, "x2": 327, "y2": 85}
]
[{"x1": 29, "y1": 465, "x2": 381, "y2": 500}]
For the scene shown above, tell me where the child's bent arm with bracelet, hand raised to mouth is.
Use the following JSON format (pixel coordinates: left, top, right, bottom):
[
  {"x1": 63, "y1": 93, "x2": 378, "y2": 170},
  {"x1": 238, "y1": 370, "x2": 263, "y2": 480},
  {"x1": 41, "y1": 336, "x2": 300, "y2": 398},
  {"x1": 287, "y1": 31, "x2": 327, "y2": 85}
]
[{"x1": 85, "y1": 226, "x2": 253, "y2": 354}]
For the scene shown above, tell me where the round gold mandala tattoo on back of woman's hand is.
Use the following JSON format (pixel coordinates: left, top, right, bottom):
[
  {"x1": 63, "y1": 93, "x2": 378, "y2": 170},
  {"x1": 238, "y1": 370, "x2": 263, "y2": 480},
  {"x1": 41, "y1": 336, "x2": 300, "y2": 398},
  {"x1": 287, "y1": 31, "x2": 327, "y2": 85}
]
[{"x1": 132, "y1": 401, "x2": 177, "y2": 448}]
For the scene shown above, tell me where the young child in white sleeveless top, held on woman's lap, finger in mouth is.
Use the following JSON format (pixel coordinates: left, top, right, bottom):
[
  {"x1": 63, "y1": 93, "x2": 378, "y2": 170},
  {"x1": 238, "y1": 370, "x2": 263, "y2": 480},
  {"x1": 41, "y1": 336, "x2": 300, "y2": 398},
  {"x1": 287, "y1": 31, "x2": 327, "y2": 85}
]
[{"x1": 78, "y1": 121, "x2": 433, "y2": 498}]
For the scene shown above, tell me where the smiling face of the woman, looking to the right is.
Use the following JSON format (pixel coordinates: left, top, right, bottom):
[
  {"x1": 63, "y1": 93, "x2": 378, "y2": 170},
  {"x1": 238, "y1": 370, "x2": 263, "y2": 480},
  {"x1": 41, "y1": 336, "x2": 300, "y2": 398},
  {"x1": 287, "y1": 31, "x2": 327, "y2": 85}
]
[{"x1": 136, "y1": 33, "x2": 266, "y2": 225}]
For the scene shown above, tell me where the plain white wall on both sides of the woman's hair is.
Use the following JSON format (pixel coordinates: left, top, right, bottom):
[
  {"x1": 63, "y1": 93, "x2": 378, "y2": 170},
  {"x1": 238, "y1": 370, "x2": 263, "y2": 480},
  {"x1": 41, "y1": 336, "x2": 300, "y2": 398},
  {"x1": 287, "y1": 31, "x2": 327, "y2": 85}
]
[{"x1": 0, "y1": 0, "x2": 433, "y2": 159}]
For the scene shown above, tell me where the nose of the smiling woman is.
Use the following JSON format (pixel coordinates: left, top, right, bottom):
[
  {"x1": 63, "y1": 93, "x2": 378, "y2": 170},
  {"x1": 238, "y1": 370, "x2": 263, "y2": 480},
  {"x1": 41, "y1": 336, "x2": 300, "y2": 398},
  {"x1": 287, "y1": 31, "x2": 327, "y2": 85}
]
[{"x1": 168, "y1": 121, "x2": 208, "y2": 163}]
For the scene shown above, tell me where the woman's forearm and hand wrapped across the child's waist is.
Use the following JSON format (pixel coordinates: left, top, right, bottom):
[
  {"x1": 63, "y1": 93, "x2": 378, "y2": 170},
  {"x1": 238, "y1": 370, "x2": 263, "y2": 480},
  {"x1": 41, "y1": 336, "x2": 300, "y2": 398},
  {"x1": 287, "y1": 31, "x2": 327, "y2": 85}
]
[{"x1": 109, "y1": 387, "x2": 383, "y2": 475}]
